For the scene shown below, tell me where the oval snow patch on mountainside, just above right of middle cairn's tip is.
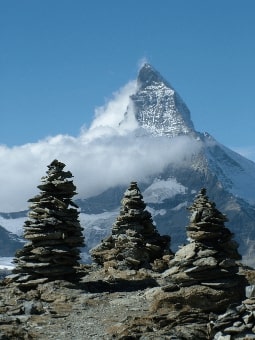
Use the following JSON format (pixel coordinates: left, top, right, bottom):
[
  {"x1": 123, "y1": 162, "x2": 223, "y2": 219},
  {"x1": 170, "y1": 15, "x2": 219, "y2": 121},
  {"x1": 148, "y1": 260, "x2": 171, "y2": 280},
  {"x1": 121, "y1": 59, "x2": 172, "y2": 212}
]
[{"x1": 143, "y1": 178, "x2": 187, "y2": 203}]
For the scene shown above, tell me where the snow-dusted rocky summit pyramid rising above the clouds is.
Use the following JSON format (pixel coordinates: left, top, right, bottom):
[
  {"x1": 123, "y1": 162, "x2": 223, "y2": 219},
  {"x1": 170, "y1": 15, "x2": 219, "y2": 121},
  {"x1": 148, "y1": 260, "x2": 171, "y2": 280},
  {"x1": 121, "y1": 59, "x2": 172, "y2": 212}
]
[{"x1": 131, "y1": 64, "x2": 195, "y2": 137}]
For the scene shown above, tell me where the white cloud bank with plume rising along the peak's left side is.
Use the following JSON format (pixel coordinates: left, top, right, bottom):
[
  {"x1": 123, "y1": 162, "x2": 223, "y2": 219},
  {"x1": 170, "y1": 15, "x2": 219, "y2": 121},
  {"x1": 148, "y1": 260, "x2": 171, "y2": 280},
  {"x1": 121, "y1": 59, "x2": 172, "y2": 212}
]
[{"x1": 0, "y1": 82, "x2": 200, "y2": 212}]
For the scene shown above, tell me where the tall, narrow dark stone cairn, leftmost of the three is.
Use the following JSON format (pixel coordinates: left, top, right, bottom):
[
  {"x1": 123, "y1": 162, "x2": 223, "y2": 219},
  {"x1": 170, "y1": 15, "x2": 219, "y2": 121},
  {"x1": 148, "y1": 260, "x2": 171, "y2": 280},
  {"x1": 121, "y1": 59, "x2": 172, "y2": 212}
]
[{"x1": 12, "y1": 160, "x2": 84, "y2": 286}]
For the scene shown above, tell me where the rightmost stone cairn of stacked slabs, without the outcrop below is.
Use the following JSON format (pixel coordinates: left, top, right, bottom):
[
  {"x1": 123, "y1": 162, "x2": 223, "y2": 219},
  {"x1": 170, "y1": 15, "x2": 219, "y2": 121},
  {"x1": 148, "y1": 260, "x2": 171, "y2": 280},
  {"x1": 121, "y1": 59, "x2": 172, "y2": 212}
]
[{"x1": 163, "y1": 189, "x2": 246, "y2": 313}]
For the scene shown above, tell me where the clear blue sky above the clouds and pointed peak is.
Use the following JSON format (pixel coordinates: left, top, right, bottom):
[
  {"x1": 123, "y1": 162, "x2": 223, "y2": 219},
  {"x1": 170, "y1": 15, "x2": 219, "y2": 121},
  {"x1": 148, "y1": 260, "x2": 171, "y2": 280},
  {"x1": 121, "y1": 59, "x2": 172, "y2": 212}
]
[{"x1": 0, "y1": 0, "x2": 255, "y2": 158}]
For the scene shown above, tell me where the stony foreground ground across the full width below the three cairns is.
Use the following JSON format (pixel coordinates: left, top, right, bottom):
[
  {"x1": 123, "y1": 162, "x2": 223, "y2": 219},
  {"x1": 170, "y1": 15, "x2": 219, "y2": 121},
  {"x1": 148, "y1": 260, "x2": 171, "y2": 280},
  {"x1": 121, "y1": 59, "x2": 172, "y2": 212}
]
[{"x1": 0, "y1": 267, "x2": 255, "y2": 340}]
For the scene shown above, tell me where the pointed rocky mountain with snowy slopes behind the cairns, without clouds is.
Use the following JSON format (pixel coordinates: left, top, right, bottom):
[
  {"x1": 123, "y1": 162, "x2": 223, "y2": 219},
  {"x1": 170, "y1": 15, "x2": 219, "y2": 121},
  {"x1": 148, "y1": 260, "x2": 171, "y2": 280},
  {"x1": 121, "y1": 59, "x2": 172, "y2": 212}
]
[{"x1": 0, "y1": 64, "x2": 255, "y2": 265}]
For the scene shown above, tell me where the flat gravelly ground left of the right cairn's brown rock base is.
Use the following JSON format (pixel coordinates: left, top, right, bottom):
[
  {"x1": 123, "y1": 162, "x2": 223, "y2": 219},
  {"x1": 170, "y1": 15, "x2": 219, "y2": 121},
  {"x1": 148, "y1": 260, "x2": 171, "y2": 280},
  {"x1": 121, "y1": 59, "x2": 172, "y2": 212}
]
[{"x1": 0, "y1": 270, "x2": 157, "y2": 340}]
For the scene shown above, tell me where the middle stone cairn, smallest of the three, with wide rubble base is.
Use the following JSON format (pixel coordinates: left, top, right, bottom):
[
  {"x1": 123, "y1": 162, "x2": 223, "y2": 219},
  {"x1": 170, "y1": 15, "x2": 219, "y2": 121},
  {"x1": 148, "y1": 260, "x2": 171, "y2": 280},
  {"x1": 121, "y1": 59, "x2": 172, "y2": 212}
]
[{"x1": 91, "y1": 182, "x2": 171, "y2": 270}]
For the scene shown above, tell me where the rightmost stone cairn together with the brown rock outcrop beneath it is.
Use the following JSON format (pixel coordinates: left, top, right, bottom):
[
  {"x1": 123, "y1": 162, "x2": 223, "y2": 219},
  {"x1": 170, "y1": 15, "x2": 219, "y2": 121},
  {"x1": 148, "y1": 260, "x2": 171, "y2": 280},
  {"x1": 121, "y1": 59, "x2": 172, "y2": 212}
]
[{"x1": 114, "y1": 189, "x2": 250, "y2": 340}]
